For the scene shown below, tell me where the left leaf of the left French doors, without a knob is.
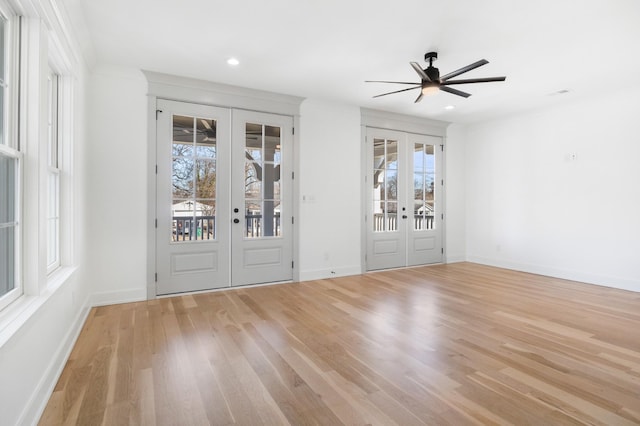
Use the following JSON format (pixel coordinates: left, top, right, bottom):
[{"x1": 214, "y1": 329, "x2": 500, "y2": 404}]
[{"x1": 156, "y1": 100, "x2": 230, "y2": 294}]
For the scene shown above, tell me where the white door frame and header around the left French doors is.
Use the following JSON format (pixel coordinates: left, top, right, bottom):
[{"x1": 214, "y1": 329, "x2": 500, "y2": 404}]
[{"x1": 142, "y1": 70, "x2": 304, "y2": 300}]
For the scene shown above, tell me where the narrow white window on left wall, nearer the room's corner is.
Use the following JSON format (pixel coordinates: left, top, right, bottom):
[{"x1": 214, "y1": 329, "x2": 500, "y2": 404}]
[{"x1": 47, "y1": 72, "x2": 60, "y2": 273}]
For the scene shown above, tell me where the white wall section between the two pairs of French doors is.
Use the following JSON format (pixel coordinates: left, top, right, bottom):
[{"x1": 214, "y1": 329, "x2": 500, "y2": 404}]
[{"x1": 298, "y1": 99, "x2": 362, "y2": 280}]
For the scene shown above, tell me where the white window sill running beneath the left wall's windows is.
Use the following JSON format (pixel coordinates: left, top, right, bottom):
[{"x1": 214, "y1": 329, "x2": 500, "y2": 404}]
[{"x1": 0, "y1": 267, "x2": 77, "y2": 348}]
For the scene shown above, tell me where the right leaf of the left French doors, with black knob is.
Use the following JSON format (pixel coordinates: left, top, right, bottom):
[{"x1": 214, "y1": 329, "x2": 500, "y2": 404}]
[{"x1": 231, "y1": 110, "x2": 293, "y2": 285}]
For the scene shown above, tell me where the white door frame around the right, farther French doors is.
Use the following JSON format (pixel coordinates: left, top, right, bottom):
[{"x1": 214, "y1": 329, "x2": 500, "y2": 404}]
[{"x1": 360, "y1": 108, "x2": 451, "y2": 272}]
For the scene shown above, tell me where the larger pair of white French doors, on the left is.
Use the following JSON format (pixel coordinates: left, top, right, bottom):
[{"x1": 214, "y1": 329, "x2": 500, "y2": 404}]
[{"x1": 156, "y1": 100, "x2": 293, "y2": 295}]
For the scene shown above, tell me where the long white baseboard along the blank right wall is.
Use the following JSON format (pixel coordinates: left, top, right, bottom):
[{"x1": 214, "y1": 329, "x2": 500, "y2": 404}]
[{"x1": 466, "y1": 256, "x2": 640, "y2": 292}]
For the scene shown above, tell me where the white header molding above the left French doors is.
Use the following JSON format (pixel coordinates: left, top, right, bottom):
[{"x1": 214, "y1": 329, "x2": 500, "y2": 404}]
[{"x1": 142, "y1": 70, "x2": 304, "y2": 116}]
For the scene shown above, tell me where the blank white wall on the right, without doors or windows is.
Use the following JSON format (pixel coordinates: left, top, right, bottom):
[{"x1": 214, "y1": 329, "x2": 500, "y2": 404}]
[{"x1": 464, "y1": 87, "x2": 640, "y2": 291}]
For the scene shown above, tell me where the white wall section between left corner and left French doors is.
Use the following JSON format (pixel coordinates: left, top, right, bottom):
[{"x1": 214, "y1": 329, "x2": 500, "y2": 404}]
[{"x1": 87, "y1": 67, "x2": 147, "y2": 304}]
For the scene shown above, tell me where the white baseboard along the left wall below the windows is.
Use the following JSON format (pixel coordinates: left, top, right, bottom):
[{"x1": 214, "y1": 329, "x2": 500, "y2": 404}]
[{"x1": 18, "y1": 297, "x2": 91, "y2": 426}]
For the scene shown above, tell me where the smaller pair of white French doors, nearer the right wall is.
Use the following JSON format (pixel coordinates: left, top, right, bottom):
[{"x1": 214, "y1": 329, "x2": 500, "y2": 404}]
[{"x1": 366, "y1": 128, "x2": 443, "y2": 270}]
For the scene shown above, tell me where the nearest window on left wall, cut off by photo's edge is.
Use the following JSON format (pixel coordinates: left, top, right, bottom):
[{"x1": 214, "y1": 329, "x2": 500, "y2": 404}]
[{"x1": 0, "y1": 12, "x2": 22, "y2": 309}]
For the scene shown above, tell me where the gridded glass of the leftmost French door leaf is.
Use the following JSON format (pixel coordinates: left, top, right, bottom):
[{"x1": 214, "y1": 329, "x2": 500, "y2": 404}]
[{"x1": 171, "y1": 115, "x2": 217, "y2": 242}]
